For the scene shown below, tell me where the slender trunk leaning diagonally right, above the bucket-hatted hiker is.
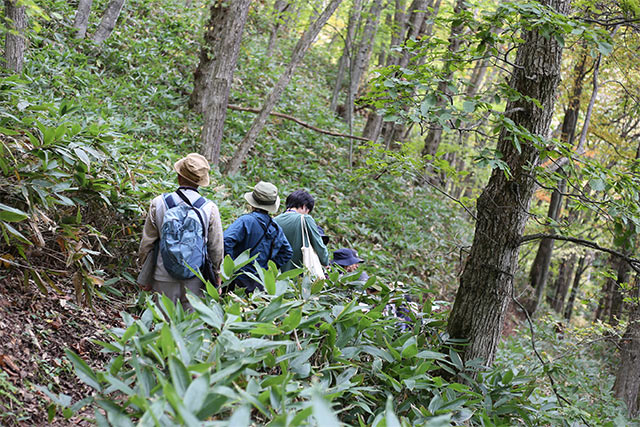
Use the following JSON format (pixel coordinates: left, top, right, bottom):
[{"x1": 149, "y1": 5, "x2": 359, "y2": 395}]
[{"x1": 226, "y1": 0, "x2": 342, "y2": 175}]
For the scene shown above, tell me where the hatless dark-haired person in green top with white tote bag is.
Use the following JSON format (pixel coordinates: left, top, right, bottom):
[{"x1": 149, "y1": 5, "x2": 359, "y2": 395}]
[{"x1": 273, "y1": 190, "x2": 329, "y2": 271}]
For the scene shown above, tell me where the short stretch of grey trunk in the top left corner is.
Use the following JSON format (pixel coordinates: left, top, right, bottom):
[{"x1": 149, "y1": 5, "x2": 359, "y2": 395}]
[{"x1": 4, "y1": 0, "x2": 27, "y2": 74}]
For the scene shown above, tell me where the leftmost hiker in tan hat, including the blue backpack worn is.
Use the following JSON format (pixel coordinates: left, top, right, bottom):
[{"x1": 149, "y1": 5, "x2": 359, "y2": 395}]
[{"x1": 138, "y1": 153, "x2": 223, "y2": 307}]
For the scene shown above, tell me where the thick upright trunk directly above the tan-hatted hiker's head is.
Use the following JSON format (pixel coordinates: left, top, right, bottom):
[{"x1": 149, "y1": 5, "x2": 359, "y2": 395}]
[{"x1": 189, "y1": 0, "x2": 251, "y2": 167}]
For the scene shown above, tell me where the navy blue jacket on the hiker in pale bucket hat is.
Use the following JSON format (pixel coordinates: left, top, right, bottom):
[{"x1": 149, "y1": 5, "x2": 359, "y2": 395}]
[{"x1": 224, "y1": 211, "x2": 293, "y2": 272}]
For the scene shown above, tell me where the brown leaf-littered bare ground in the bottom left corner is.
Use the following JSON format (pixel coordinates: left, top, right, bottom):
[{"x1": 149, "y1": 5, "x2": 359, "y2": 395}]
[{"x1": 0, "y1": 270, "x2": 129, "y2": 426}]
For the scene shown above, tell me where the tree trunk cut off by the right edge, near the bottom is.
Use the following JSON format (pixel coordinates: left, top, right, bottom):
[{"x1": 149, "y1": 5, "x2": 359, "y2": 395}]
[{"x1": 613, "y1": 277, "x2": 640, "y2": 418}]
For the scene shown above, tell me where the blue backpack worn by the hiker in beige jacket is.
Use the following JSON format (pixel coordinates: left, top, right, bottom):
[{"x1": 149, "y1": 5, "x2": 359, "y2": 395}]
[{"x1": 160, "y1": 190, "x2": 207, "y2": 280}]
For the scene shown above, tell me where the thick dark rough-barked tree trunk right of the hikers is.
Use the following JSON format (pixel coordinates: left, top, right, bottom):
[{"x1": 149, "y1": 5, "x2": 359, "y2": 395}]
[{"x1": 447, "y1": 0, "x2": 569, "y2": 365}]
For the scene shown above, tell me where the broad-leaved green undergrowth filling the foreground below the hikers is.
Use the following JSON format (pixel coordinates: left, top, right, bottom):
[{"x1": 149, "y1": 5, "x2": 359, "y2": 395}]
[{"x1": 43, "y1": 260, "x2": 558, "y2": 426}]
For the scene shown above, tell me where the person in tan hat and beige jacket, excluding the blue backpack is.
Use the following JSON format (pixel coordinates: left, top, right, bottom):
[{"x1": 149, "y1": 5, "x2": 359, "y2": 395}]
[{"x1": 138, "y1": 153, "x2": 223, "y2": 306}]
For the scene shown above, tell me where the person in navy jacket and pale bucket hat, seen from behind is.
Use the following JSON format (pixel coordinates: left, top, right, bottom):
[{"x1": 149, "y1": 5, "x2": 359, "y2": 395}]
[{"x1": 224, "y1": 181, "x2": 292, "y2": 293}]
